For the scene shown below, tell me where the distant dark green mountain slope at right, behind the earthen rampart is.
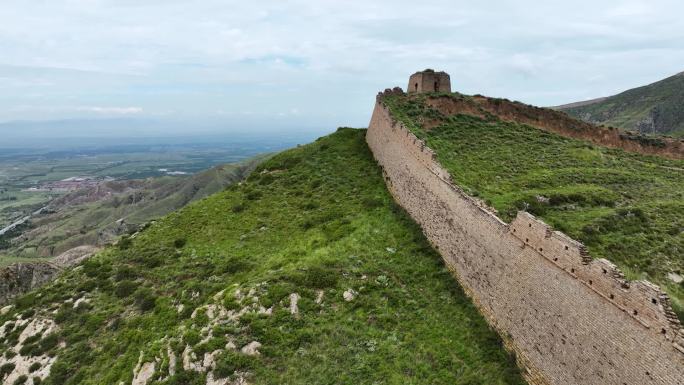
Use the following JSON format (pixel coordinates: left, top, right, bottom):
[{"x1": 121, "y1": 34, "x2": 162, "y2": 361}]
[{"x1": 555, "y1": 72, "x2": 684, "y2": 137}]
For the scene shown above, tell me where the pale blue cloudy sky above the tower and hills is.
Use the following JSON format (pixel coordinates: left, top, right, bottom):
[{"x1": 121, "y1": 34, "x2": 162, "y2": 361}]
[{"x1": 0, "y1": 0, "x2": 684, "y2": 134}]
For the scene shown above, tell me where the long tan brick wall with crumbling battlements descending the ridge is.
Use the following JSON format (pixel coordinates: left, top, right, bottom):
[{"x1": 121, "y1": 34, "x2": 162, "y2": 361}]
[{"x1": 367, "y1": 90, "x2": 684, "y2": 385}]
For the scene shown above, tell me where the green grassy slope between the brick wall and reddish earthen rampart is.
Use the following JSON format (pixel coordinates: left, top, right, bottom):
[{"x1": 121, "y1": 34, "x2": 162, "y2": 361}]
[{"x1": 385, "y1": 95, "x2": 684, "y2": 318}]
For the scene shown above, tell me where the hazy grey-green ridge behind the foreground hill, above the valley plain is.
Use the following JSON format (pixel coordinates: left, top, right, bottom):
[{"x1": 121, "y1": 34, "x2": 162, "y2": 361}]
[{"x1": 0, "y1": 157, "x2": 264, "y2": 263}]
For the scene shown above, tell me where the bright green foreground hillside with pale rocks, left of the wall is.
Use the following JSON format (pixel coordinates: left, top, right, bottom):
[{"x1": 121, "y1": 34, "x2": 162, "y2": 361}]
[{"x1": 0, "y1": 129, "x2": 523, "y2": 385}]
